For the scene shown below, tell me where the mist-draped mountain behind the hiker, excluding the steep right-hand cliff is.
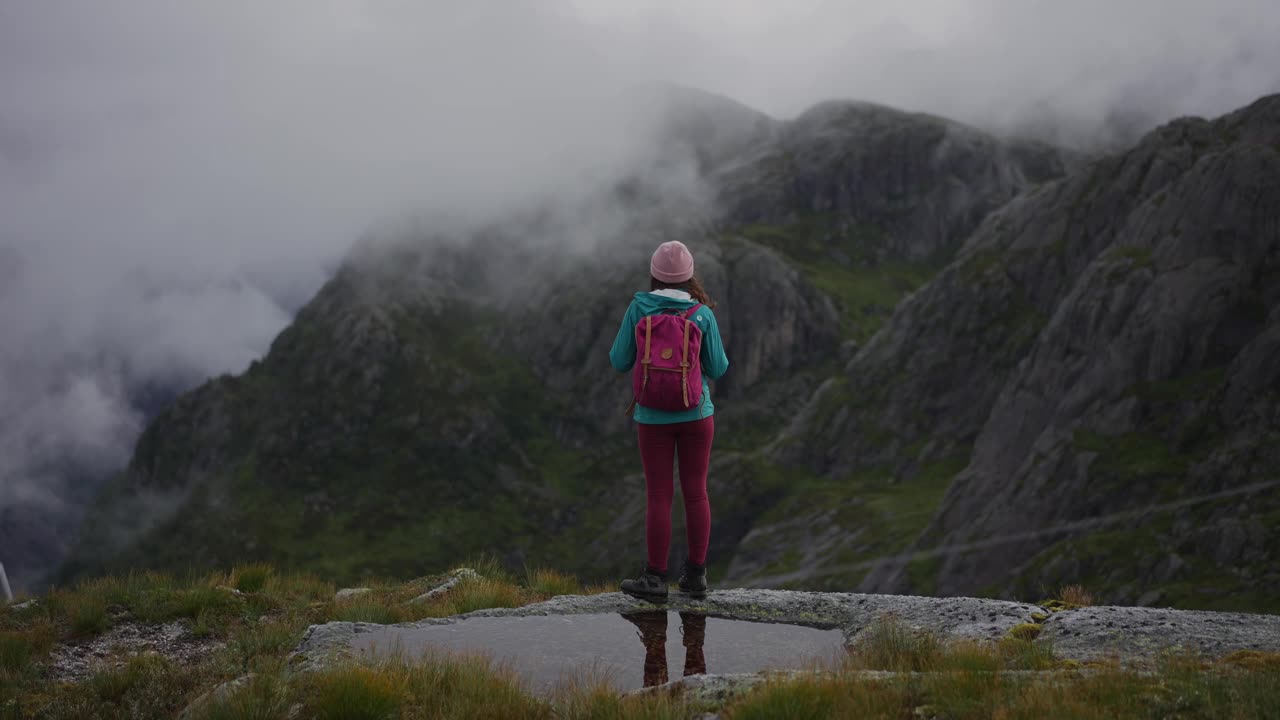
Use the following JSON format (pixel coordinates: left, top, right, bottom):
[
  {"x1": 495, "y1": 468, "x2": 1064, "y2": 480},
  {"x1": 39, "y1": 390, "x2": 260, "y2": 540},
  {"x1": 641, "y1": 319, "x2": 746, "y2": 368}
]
[{"x1": 63, "y1": 89, "x2": 1090, "y2": 591}]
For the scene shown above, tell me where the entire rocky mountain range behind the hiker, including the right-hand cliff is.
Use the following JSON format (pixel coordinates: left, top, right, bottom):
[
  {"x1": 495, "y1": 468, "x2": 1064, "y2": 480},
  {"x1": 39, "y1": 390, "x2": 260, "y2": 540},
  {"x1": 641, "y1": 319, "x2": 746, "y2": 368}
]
[{"x1": 55, "y1": 95, "x2": 1280, "y2": 606}]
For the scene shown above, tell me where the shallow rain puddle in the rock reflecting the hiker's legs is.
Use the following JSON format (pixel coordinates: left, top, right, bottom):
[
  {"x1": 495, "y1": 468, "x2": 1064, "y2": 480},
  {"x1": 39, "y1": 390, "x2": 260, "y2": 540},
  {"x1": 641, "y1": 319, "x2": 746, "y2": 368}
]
[{"x1": 352, "y1": 611, "x2": 845, "y2": 693}]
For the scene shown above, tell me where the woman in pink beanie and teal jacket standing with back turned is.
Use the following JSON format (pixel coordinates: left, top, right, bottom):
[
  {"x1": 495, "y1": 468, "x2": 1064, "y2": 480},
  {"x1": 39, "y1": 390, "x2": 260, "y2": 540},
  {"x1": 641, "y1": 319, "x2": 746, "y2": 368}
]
[{"x1": 609, "y1": 241, "x2": 728, "y2": 602}]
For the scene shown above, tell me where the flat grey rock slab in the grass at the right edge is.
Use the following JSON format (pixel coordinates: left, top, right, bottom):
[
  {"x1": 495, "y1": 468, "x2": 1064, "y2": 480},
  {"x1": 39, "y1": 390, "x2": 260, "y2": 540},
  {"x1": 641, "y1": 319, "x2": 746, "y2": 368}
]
[{"x1": 1037, "y1": 607, "x2": 1280, "y2": 660}]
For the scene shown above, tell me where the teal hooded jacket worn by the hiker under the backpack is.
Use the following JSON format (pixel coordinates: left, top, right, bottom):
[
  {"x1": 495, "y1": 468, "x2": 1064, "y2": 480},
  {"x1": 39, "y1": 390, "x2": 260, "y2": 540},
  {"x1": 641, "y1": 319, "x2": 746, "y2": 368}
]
[{"x1": 609, "y1": 286, "x2": 728, "y2": 425}]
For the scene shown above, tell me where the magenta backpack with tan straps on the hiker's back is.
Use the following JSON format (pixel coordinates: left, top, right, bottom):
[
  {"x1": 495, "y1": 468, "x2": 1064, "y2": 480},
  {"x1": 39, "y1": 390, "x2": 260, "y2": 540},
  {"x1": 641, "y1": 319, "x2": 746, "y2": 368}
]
[{"x1": 631, "y1": 304, "x2": 703, "y2": 413}]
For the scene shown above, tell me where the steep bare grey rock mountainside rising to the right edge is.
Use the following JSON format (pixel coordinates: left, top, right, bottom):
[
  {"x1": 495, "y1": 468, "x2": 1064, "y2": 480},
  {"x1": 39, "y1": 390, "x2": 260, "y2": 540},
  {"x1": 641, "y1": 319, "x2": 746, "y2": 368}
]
[{"x1": 762, "y1": 90, "x2": 1280, "y2": 606}]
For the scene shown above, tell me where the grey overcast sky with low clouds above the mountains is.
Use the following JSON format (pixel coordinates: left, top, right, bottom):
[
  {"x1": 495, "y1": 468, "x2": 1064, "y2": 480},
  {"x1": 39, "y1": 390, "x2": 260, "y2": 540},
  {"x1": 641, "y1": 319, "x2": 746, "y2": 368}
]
[{"x1": 0, "y1": 0, "x2": 1280, "y2": 576}]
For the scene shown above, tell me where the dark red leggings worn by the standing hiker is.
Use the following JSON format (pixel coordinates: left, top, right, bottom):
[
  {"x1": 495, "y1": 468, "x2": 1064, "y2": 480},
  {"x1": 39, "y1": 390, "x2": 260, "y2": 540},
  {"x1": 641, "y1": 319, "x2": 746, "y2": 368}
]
[{"x1": 637, "y1": 418, "x2": 716, "y2": 571}]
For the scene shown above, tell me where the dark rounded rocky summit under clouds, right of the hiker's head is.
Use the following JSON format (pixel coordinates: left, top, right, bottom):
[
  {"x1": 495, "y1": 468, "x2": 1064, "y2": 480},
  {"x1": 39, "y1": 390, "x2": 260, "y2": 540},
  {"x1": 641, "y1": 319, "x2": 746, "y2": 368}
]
[{"x1": 718, "y1": 101, "x2": 1065, "y2": 260}]
